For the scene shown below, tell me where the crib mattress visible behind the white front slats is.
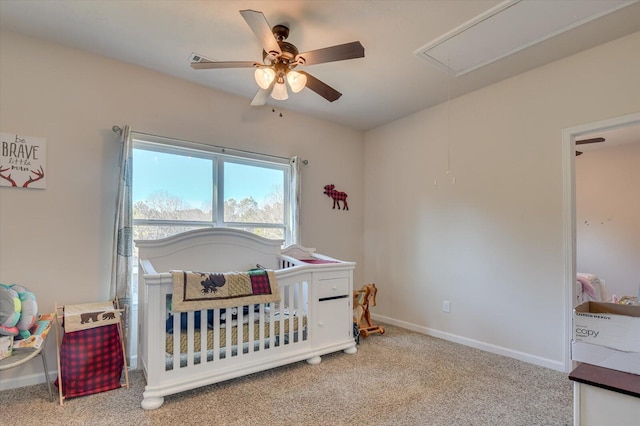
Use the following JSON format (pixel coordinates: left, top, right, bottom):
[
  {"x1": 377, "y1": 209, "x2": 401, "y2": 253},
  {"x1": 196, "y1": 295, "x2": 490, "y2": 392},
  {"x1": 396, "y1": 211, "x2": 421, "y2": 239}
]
[{"x1": 165, "y1": 316, "x2": 307, "y2": 355}]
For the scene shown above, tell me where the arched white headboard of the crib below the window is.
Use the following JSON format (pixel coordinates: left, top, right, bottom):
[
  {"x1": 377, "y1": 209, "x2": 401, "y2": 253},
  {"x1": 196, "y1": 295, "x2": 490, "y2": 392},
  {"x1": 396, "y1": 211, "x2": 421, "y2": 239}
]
[{"x1": 135, "y1": 228, "x2": 283, "y2": 273}]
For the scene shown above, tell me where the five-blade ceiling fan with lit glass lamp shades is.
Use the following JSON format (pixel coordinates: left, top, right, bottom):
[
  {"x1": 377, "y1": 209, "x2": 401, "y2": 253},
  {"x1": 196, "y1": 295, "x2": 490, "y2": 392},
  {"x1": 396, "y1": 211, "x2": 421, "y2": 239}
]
[{"x1": 191, "y1": 10, "x2": 364, "y2": 106}]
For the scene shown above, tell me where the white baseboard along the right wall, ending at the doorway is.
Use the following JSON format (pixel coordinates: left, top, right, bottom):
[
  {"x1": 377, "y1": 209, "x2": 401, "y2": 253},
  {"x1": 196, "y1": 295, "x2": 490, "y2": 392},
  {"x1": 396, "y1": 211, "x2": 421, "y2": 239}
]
[{"x1": 371, "y1": 314, "x2": 565, "y2": 372}]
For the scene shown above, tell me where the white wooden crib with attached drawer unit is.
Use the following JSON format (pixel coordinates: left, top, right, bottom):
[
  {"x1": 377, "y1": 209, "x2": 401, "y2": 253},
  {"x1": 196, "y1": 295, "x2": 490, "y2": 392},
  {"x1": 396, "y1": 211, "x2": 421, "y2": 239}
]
[{"x1": 136, "y1": 228, "x2": 357, "y2": 410}]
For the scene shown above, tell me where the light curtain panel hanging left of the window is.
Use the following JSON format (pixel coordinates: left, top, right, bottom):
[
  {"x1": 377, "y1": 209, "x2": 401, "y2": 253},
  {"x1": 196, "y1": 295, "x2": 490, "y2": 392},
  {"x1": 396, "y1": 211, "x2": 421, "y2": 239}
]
[{"x1": 109, "y1": 126, "x2": 133, "y2": 304}]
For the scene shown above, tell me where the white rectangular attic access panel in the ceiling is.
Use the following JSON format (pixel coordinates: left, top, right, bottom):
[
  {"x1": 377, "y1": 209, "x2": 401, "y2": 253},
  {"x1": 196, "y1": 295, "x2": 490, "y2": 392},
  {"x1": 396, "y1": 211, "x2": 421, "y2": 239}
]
[{"x1": 414, "y1": 0, "x2": 638, "y2": 77}]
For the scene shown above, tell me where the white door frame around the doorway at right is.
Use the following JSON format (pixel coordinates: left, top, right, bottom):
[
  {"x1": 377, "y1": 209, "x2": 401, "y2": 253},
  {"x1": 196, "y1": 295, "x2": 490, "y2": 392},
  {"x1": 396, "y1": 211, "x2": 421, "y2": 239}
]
[{"x1": 562, "y1": 112, "x2": 640, "y2": 373}]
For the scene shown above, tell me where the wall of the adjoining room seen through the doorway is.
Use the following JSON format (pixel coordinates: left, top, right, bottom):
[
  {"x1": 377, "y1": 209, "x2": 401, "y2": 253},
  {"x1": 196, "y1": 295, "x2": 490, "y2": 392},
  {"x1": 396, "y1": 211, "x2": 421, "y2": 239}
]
[{"x1": 576, "y1": 141, "x2": 640, "y2": 297}]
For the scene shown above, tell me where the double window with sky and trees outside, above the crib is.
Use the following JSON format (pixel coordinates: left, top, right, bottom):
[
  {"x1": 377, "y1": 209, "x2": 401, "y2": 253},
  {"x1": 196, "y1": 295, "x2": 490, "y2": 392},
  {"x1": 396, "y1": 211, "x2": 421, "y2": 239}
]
[{"x1": 132, "y1": 134, "x2": 296, "y2": 244}]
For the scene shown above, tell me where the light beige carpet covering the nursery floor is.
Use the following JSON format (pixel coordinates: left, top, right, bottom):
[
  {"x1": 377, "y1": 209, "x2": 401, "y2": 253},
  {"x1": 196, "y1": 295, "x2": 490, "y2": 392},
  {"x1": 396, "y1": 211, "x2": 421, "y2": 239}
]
[{"x1": 0, "y1": 326, "x2": 573, "y2": 426}]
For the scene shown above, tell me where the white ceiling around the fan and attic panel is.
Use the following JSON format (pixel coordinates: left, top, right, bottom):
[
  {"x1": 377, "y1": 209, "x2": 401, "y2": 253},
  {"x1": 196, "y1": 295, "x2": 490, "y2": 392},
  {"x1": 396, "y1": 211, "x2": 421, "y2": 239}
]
[{"x1": 0, "y1": 0, "x2": 640, "y2": 130}]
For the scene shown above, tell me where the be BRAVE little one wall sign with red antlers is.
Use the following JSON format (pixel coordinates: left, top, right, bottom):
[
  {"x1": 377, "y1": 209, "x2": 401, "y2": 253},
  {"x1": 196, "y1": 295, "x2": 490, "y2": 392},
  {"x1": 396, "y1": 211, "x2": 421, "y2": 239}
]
[{"x1": 0, "y1": 132, "x2": 47, "y2": 189}]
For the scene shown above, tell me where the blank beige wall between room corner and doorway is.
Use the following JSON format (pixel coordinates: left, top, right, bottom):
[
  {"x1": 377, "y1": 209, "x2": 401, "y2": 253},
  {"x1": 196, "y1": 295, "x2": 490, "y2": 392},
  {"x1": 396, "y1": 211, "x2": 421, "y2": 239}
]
[{"x1": 364, "y1": 33, "x2": 640, "y2": 369}]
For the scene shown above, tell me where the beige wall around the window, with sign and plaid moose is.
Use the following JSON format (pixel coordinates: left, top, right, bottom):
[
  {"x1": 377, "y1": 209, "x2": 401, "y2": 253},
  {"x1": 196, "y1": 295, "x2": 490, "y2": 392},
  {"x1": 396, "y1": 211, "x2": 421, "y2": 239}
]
[{"x1": 0, "y1": 32, "x2": 364, "y2": 389}]
